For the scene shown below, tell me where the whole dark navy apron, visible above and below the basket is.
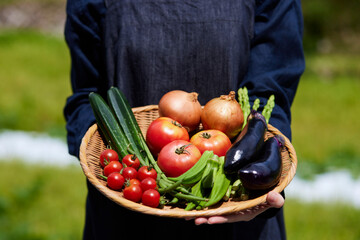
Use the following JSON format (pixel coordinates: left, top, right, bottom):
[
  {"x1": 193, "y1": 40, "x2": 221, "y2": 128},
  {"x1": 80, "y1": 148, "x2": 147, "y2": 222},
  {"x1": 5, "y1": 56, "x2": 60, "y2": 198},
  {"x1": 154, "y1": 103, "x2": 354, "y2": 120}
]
[{"x1": 84, "y1": 0, "x2": 285, "y2": 240}]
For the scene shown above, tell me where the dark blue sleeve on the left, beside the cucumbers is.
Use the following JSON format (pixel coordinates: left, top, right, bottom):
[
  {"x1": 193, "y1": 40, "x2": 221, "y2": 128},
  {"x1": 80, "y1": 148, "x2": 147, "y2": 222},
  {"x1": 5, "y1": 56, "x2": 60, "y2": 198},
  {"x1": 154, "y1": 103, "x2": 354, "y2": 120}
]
[{"x1": 64, "y1": 0, "x2": 105, "y2": 157}]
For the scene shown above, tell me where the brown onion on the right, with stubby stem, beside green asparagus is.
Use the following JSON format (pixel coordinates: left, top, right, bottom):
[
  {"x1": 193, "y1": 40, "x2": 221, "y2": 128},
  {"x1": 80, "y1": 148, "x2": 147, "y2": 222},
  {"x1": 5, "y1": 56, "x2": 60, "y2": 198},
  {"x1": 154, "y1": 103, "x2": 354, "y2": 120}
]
[{"x1": 201, "y1": 91, "x2": 244, "y2": 139}]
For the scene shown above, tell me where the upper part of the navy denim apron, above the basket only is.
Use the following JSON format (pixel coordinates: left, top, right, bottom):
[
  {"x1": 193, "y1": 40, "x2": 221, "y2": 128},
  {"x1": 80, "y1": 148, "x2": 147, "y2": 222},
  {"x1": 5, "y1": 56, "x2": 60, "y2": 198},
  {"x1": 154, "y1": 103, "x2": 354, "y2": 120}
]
[{"x1": 105, "y1": 0, "x2": 255, "y2": 106}]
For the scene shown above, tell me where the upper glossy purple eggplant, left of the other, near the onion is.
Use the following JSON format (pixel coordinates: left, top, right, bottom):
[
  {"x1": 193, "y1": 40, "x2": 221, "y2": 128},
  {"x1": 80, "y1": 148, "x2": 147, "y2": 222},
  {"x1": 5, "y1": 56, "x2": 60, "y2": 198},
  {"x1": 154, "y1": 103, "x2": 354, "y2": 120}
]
[{"x1": 224, "y1": 110, "x2": 267, "y2": 175}]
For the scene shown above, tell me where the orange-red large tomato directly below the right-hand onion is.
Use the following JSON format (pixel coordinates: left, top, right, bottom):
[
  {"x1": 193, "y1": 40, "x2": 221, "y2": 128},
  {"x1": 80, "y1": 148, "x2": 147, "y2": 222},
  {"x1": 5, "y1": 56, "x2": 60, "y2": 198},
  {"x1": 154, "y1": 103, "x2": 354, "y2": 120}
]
[{"x1": 190, "y1": 130, "x2": 231, "y2": 157}]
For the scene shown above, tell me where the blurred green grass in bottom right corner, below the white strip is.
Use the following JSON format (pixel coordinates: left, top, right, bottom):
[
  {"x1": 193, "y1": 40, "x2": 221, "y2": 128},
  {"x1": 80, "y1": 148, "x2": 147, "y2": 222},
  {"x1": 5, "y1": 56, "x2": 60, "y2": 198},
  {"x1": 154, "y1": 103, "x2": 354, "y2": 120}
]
[{"x1": 284, "y1": 199, "x2": 360, "y2": 240}]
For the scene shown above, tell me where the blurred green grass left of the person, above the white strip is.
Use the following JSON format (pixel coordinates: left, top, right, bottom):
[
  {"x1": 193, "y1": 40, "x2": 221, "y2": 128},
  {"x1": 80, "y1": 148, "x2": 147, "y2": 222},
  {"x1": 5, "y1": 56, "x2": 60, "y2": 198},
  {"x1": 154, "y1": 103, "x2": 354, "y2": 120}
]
[{"x1": 0, "y1": 30, "x2": 71, "y2": 136}]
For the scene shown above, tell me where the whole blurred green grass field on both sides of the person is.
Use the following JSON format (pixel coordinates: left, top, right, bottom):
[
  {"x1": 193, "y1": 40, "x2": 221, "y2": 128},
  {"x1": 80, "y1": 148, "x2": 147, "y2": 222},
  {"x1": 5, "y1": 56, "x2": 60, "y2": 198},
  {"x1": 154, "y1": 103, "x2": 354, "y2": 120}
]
[{"x1": 0, "y1": 0, "x2": 360, "y2": 240}]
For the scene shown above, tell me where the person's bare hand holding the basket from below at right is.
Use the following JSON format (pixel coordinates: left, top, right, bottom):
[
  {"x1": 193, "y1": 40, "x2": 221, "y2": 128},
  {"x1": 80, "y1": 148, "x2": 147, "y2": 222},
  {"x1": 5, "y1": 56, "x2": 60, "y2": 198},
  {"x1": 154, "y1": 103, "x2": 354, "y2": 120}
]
[{"x1": 191, "y1": 191, "x2": 285, "y2": 225}]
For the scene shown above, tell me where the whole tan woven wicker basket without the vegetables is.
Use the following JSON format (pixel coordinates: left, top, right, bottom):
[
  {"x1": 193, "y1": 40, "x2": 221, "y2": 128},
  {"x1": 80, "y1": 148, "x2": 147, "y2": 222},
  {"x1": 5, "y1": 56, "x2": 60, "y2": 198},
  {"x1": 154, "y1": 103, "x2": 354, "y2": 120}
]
[{"x1": 80, "y1": 105, "x2": 297, "y2": 218}]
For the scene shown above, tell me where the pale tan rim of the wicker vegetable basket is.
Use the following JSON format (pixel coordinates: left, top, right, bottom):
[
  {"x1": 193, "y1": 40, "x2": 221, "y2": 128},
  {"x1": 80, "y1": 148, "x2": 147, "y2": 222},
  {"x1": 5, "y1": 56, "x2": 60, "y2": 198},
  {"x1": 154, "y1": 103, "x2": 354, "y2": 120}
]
[{"x1": 79, "y1": 105, "x2": 297, "y2": 218}]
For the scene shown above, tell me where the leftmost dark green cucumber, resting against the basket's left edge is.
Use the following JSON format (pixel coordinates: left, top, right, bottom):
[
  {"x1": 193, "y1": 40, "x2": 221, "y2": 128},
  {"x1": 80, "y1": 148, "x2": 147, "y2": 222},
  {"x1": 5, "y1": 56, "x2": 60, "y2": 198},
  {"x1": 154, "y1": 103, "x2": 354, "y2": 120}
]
[{"x1": 89, "y1": 92, "x2": 129, "y2": 158}]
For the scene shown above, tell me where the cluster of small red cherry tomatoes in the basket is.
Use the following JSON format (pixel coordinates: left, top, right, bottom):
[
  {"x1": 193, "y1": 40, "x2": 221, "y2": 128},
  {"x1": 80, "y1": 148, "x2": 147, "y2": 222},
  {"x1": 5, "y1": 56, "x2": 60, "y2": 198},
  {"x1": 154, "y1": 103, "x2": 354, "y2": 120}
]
[{"x1": 100, "y1": 149, "x2": 160, "y2": 207}]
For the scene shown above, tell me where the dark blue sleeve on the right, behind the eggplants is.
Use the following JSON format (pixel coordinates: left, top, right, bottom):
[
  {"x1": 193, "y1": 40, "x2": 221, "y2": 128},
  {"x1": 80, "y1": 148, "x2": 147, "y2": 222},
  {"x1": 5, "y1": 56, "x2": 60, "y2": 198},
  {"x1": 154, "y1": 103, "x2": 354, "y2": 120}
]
[{"x1": 242, "y1": 0, "x2": 305, "y2": 139}]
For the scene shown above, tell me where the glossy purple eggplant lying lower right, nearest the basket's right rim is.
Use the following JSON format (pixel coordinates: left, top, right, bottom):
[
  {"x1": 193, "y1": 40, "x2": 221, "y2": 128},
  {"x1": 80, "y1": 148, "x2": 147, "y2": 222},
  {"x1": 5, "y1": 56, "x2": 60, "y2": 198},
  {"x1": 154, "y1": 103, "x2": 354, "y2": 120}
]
[{"x1": 238, "y1": 135, "x2": 284, "y2": 190}]
